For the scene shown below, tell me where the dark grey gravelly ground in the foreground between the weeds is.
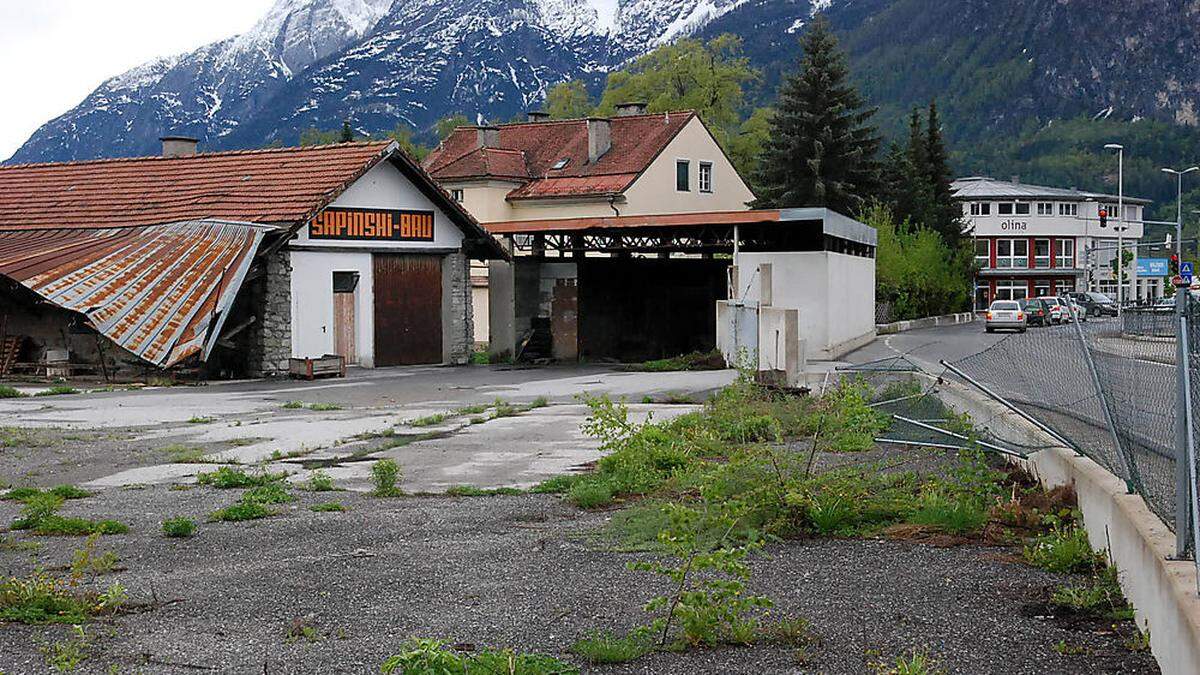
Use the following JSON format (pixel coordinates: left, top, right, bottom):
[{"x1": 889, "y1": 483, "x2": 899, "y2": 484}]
[{"x1": 0, "y1": 486, "x2": 1158, "y2": 675}]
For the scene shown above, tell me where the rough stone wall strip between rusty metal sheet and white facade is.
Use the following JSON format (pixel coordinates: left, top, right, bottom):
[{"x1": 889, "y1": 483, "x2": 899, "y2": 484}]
[{"x1": 247, "y1": 249, "x2": 292, "y2": 377}]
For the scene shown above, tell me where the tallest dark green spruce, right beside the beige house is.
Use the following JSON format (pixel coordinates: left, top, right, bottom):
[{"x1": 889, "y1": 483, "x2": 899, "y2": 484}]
[{"x1": 754, "y1": 17, "x2": 880, "y2": 214}]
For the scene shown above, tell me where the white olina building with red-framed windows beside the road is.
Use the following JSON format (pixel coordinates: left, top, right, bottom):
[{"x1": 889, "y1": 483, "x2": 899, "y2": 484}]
[{"x1": 953, "y1": 177, "x2": 1163, "y2": 309}]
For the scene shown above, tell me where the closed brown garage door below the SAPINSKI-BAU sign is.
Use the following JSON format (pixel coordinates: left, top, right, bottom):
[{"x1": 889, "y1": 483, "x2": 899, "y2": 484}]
[{"x1": 372, "y1": 253, "x2": 442, "y2": 365}]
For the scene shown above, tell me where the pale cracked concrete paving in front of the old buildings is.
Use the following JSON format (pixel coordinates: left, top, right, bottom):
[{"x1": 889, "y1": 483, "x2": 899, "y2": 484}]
[{"x1": 0, "y1": 366, "x2": 734, "y2": 491}]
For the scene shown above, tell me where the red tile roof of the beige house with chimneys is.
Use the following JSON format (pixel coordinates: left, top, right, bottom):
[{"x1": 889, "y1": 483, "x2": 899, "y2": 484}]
[{"x1": 425, "y1": 110, "x2": 696, "y2": 199}]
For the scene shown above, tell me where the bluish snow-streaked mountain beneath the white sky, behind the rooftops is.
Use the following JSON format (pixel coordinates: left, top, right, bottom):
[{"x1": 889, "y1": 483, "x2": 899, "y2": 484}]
[{"x1": 11, "y1": 0, "x2": 758, "y2": 162}]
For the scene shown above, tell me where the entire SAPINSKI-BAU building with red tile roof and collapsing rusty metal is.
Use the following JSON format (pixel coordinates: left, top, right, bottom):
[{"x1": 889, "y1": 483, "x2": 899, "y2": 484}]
[{"x1": 0, "y1": 138, "x2": 508, "y2": 375}]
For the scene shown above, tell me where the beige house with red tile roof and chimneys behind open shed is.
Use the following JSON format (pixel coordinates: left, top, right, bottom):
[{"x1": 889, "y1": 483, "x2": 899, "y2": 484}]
[{"x1": 424, "y1": 103, "x2": 754, "y2": 342}]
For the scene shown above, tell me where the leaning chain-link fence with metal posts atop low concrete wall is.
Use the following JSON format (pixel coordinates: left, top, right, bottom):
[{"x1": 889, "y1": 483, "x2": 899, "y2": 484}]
[{"x1": 948, "y1": 297, "x2": 1200, "y2": 557}]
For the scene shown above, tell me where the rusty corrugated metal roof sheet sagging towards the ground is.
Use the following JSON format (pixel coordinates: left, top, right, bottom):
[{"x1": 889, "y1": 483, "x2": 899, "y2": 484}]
[{"x1": 0, "y1": 220, "x2": 266, "y2": 368}]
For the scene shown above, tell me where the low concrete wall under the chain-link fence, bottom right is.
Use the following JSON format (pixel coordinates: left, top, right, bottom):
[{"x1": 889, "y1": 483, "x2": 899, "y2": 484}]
[{"x1": 938, "y1": 374, "x2": 1200, "y2": 674}]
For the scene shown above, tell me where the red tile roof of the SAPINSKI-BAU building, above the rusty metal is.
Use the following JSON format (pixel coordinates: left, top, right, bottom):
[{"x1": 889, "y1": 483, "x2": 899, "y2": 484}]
[{"x1": 0, "y1": 141, "x2": 391, "y2": 229}]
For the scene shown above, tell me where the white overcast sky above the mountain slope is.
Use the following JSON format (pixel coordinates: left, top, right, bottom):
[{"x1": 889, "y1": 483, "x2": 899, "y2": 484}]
[{"x1": 0, "y1": 0, "x2": 272, "y2": 160}]
